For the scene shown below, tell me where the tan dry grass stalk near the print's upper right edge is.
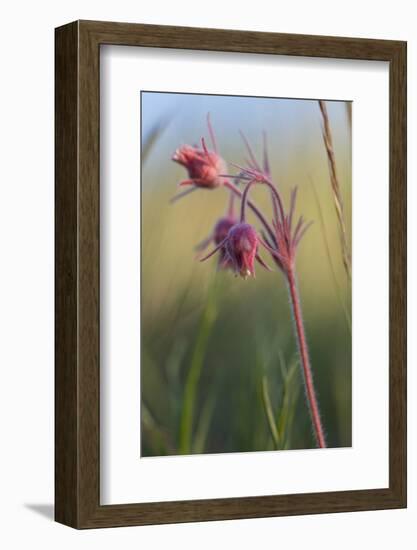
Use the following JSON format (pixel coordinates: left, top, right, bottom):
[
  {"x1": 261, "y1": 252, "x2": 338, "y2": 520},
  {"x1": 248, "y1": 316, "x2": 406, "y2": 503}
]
[{"x1": 319, "y1": 100, "x2": 352, "y2": 279}]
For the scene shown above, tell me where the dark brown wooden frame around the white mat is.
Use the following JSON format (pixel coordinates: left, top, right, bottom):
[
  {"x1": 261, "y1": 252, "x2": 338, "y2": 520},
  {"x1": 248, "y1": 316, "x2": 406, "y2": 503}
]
[{"x1": 55, "y1": 21, "x2": 407, "y2": 528}]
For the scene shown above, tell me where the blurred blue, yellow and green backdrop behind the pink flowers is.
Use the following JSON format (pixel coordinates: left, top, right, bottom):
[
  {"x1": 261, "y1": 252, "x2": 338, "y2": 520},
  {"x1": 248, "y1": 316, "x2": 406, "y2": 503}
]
[{"x1": 140, "y1": 92, "x2": 352, "y2": 456}]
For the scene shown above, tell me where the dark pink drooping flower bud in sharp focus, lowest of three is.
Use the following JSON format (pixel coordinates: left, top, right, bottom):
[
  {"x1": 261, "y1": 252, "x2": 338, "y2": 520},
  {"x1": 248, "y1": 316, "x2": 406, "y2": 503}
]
[{"x1": 225, "y1": 223, "x2": 259, "y2": 279}]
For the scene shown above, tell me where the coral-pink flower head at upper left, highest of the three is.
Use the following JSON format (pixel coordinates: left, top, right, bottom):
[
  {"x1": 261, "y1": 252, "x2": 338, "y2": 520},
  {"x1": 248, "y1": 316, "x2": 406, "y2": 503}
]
[{"x1": 172, "y1": 142, "x2": 226, "y2": 189}]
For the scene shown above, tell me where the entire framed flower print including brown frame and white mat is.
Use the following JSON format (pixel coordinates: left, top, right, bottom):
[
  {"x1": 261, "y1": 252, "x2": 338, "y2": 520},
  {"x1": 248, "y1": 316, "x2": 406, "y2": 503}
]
[{"x1": 55, "y1": 21, "x2": 406, "y2": 528}]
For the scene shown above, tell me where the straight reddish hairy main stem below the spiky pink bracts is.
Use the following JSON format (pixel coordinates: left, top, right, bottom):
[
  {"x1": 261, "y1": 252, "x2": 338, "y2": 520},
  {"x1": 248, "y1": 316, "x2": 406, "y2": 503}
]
[{"x1": 287, "y1": 268, "x2": 326, "y2": 448}]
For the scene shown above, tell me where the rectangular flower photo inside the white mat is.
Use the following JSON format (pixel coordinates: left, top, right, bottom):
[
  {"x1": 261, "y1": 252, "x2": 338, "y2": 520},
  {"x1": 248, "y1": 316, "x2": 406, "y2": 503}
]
[{"x1": 138, "y1": 90, "x2": 352, "y2": 457}]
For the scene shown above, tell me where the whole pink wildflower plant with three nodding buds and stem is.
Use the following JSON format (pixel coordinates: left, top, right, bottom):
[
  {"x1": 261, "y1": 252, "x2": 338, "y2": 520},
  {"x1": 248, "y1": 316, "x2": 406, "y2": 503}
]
[{"x1": 173, "y1": 117, "x2": 326, "y2": 448}]
